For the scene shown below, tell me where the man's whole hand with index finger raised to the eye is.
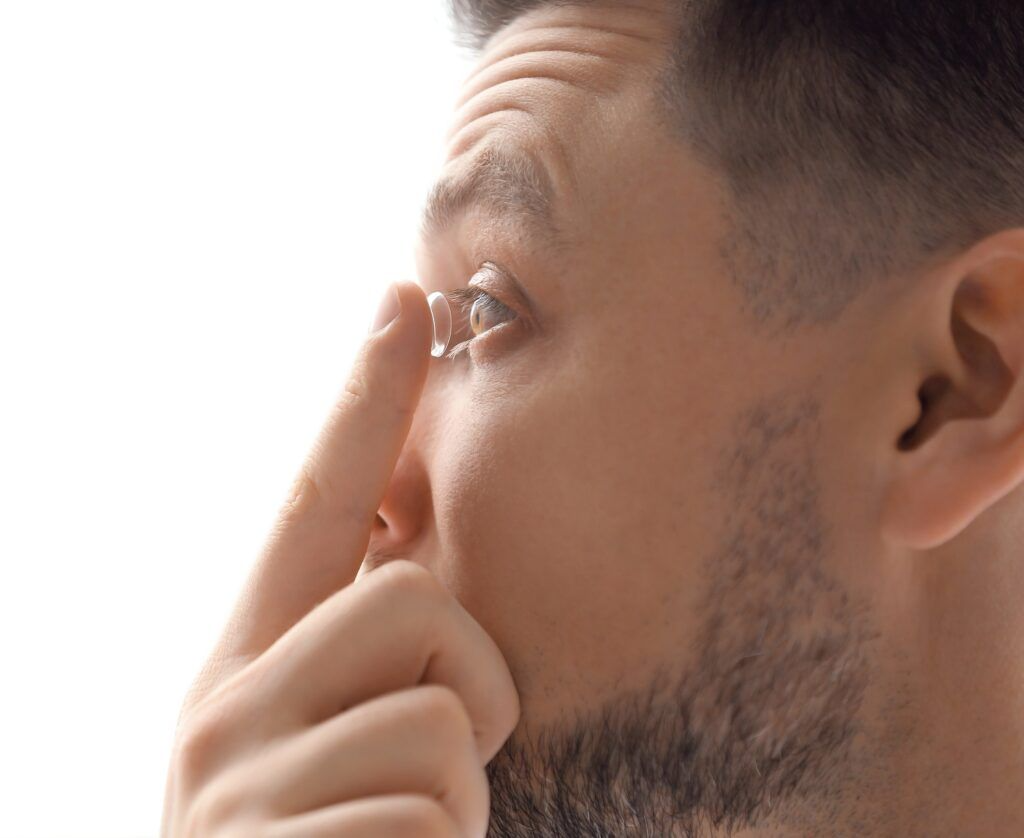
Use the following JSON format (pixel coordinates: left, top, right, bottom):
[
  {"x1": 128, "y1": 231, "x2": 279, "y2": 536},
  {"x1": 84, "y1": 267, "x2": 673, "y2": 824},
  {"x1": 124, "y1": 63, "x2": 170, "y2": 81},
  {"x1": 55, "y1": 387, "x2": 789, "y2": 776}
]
[{"x1": 161, "y1": 283, "x2": 519, "y2": 838}]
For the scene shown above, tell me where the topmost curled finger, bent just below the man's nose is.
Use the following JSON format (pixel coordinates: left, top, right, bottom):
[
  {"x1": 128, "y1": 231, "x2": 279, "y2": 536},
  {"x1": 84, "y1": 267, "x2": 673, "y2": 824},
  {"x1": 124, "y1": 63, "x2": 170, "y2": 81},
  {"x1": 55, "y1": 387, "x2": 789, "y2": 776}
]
[{"x1": 231, "y1": 559, "x2": 520, "y2": 764}]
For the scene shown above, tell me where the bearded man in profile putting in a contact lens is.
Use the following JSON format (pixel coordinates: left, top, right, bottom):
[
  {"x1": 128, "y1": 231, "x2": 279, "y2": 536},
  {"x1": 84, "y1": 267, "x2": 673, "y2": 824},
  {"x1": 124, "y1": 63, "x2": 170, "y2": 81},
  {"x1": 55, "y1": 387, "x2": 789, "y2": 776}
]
[{"x1": 155, "y1": 0, "x2": 1024, "y2": 836}]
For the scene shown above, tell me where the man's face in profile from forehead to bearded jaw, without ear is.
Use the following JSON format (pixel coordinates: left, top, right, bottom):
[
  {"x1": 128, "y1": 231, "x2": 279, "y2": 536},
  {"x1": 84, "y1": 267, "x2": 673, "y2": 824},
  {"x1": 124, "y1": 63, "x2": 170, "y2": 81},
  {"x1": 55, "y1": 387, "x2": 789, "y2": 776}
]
[{"x1": 381, "y1": 1, "x2": 901, "y2": 834}]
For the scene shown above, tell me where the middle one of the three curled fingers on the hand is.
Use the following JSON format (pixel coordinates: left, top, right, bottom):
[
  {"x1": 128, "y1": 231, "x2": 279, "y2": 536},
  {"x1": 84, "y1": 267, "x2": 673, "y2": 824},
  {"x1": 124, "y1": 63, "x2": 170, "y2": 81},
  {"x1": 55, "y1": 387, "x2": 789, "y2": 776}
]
[{"x1": 247, "y1": 685, "x2": 490, "y2": 835}]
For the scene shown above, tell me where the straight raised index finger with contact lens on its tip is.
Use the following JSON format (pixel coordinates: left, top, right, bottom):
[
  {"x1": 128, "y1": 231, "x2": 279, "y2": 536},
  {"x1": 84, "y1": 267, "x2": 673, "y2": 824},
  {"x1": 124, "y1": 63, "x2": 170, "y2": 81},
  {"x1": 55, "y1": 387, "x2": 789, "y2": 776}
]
[{"x1": 217, "y1": 283, "x2": 433, "y2": 659}]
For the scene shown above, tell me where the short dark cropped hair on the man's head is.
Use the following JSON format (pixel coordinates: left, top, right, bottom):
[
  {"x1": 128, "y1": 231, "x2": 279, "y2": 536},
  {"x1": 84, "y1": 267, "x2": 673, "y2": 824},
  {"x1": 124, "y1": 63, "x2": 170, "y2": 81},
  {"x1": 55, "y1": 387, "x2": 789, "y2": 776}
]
[{"x1": 451, "y1": 0, "x2": 1024, "y2": 328}]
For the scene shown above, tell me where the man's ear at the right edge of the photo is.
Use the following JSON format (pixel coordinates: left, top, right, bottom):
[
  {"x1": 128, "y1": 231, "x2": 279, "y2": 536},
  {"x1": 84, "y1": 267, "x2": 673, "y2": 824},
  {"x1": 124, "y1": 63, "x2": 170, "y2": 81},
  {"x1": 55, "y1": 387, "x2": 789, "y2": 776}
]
[{"x1": 883, "y1": 229, "x2": 1024, "y2": 550}]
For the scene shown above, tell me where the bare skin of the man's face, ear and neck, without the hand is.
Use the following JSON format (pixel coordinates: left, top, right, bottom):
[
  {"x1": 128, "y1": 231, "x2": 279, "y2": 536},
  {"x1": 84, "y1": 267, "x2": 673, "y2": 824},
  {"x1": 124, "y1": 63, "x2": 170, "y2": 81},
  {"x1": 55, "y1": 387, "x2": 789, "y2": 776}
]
[{"x1": 401, "y1": 4, "x2": 1024, "y2": 835}]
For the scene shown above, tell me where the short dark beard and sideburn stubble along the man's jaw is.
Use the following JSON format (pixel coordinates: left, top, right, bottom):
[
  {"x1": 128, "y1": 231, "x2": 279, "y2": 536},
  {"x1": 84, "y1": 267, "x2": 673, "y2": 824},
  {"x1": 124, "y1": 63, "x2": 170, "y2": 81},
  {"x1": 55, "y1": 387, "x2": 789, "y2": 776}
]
[{"x1": 486, "y1": 394, "x2": 873, "y2": 838}]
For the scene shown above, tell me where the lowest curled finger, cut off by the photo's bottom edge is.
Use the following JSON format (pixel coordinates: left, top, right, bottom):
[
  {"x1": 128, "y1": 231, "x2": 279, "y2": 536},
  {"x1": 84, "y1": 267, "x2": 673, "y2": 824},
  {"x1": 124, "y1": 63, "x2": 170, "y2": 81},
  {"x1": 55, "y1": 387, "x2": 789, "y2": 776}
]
[{"x1": 260, "y1": 794, "x2": 460, "y2": 838}]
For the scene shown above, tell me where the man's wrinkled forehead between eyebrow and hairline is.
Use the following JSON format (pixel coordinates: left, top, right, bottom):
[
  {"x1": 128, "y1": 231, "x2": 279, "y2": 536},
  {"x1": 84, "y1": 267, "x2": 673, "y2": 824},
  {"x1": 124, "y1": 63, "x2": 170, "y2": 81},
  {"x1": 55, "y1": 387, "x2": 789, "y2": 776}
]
[{"x1": 445, "y1": 2, "x2": 674, "y2": 195}]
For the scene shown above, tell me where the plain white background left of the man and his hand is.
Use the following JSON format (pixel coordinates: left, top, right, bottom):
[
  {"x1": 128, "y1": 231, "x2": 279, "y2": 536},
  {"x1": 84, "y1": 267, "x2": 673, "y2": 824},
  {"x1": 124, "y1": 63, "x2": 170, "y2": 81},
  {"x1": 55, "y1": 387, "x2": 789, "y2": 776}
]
[{"x1": 0, "y1": 0, "x2": 471, "y2": 838}]
